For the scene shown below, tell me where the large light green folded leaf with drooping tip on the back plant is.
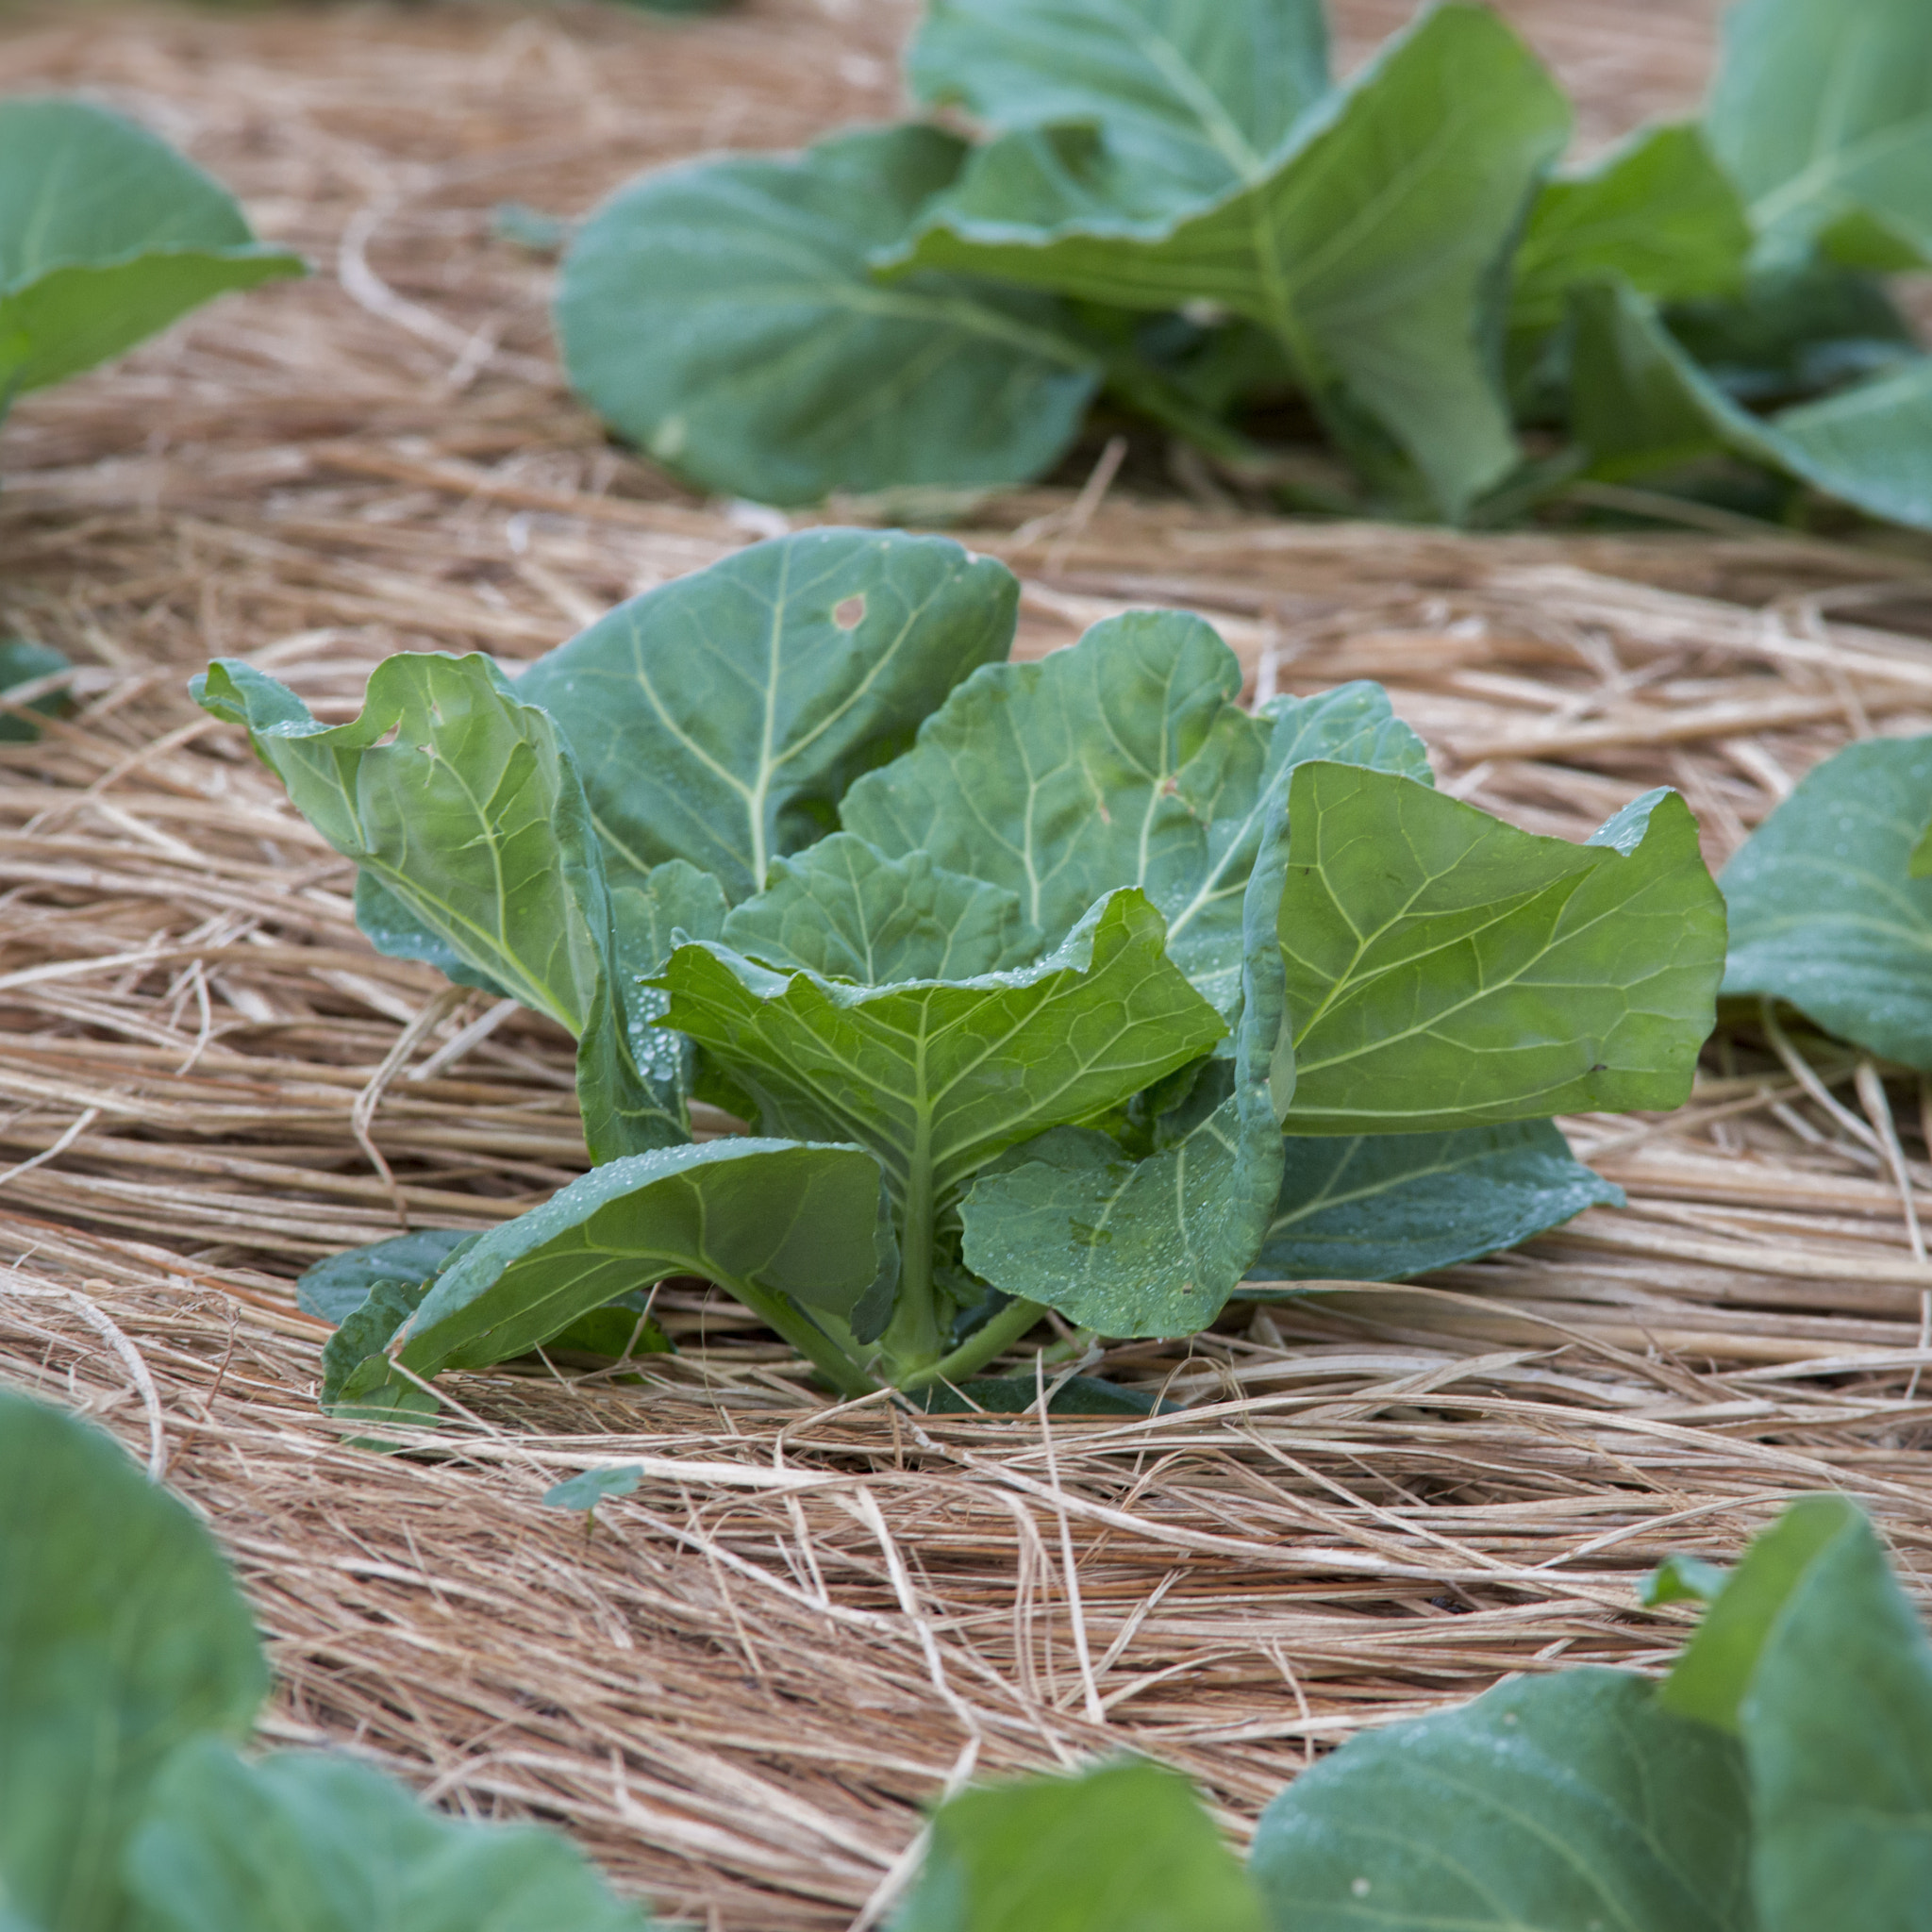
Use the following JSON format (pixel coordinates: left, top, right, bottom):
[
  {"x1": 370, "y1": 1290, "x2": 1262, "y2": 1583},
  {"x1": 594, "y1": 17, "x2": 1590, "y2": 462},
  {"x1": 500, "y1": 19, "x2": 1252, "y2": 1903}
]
[{"x1": 879, "y1": 0, "x2": 1569, "y2": 514}]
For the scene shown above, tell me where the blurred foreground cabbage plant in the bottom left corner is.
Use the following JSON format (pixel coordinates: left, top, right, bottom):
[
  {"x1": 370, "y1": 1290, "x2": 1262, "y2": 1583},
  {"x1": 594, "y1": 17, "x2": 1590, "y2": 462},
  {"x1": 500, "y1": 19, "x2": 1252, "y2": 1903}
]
[{"x1": 0, "y1": 1393, "x2": 645, "y2": 1932}]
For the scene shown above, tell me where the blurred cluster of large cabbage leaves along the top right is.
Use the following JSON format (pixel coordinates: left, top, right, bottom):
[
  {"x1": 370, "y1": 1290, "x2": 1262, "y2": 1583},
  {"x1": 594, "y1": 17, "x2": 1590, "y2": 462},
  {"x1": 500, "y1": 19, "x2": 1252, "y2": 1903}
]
[{"x1": 557, "y1": 0, "x2": 1932, "y2": 527}]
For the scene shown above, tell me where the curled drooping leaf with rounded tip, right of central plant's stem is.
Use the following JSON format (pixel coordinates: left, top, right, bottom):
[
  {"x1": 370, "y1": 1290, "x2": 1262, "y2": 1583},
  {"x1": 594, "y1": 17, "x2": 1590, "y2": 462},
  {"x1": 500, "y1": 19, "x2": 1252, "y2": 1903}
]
[{"x1": 960, "y1": 794, "x2": 1294, "y2": 1335}]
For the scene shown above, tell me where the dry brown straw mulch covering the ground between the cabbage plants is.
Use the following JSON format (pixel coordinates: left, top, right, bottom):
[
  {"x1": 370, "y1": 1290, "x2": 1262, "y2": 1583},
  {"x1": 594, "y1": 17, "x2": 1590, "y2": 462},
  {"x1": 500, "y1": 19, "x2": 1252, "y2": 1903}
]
[{"x1": 0, "y1": 0, "x2": 1932, "y2": 1932}]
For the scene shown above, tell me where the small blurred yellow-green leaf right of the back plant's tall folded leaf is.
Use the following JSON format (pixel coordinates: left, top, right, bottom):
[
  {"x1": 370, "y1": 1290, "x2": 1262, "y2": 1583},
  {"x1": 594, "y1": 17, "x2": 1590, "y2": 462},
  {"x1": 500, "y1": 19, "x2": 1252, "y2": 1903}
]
[{"x1": 1508, "y1": 125, "x2": 1750, "y2": 330}]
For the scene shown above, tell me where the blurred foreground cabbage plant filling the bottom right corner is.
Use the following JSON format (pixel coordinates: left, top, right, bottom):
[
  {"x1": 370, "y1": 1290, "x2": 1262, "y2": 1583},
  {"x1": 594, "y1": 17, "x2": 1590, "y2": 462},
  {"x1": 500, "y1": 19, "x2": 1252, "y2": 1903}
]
[{"x1": 892, "y1": 1495, "x2": 1932, "y2": 1932}]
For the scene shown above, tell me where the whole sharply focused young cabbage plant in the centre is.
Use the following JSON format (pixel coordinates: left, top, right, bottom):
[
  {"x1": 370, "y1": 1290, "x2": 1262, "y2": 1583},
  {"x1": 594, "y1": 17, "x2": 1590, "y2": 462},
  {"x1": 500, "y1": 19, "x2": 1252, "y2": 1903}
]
[{"x1": 195, "y1": 529, "x2": 1724, "y2": 1410}]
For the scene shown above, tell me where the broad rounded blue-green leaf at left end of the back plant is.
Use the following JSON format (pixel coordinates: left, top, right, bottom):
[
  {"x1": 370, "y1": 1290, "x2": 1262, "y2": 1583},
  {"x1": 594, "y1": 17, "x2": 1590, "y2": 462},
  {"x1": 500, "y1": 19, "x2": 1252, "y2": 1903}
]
[{"x1": 557, "y1": 127, "x2": 1099, "y2": 502}]
